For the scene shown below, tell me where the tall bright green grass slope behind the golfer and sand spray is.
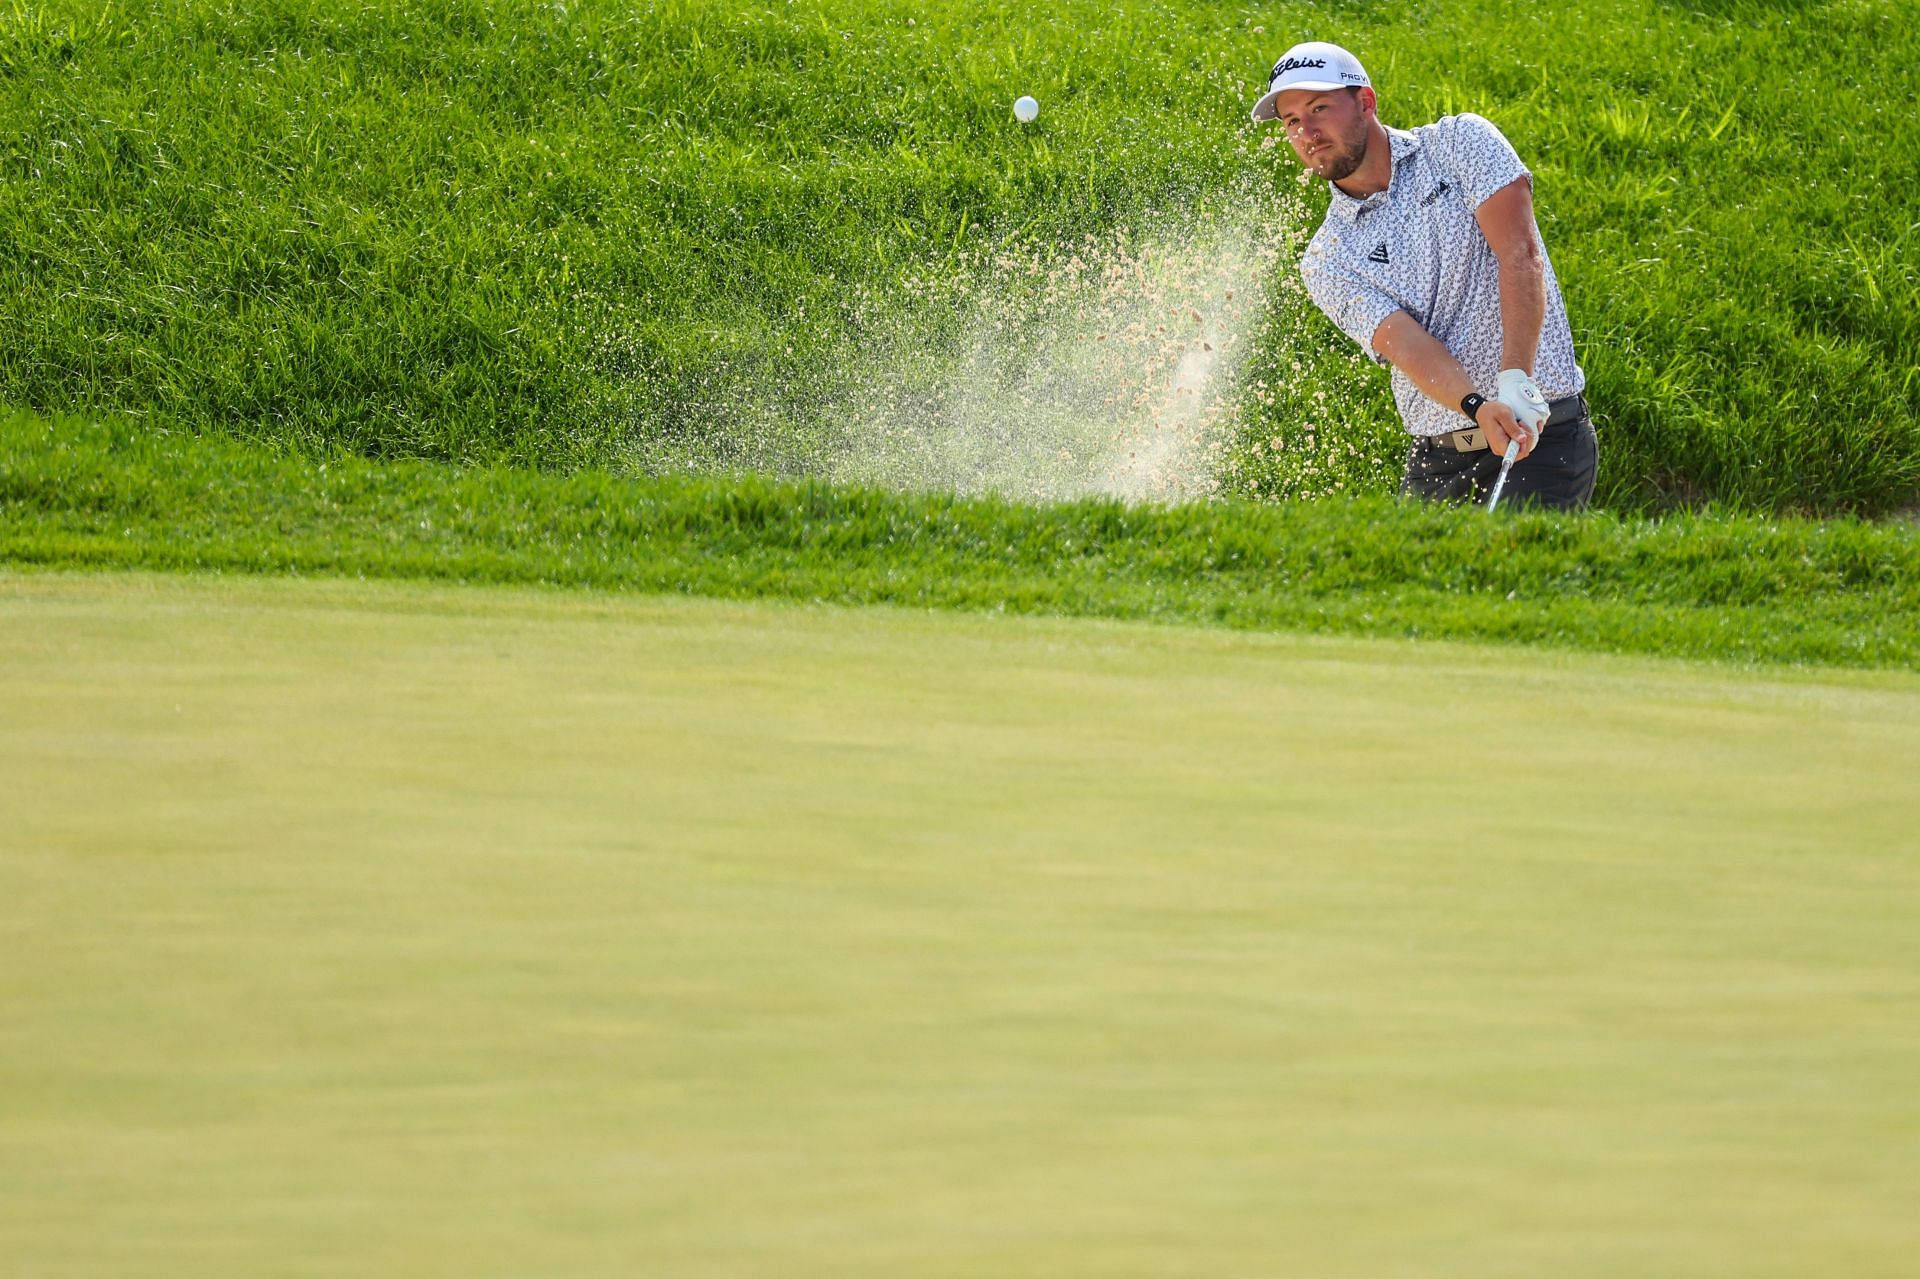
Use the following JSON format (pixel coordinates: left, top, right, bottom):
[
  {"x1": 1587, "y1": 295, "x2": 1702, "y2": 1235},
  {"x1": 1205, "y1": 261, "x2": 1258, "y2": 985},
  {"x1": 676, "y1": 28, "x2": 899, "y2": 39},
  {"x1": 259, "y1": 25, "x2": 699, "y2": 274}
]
[{"x1": 0, "y1": 0, "x2": 1920, "y2": 515}]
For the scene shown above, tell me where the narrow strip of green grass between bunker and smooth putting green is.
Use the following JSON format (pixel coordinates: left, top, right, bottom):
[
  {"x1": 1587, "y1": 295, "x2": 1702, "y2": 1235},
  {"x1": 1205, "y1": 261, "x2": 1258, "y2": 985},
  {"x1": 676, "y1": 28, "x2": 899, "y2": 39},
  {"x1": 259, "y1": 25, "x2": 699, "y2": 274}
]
[{"x1": 0, "y1": 415, "x2": 1920, "y2": 668}]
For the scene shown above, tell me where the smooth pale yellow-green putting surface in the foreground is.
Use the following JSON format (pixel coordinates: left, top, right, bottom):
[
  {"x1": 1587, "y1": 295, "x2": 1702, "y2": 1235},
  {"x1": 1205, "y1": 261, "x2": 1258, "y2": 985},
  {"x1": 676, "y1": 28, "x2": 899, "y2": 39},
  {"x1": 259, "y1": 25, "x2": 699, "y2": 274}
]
[{"x1": 0, "y1": 574, "x2": 1920, "y2": 1279}]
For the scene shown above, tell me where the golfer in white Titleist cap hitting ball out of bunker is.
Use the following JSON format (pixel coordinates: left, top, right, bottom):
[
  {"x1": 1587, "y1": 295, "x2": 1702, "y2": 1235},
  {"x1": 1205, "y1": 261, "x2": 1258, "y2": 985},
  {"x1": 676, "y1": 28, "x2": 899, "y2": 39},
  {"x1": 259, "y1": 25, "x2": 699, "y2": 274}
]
[{"x1": 1254, "y1": 42, "x2": 1599, "y2": 511}]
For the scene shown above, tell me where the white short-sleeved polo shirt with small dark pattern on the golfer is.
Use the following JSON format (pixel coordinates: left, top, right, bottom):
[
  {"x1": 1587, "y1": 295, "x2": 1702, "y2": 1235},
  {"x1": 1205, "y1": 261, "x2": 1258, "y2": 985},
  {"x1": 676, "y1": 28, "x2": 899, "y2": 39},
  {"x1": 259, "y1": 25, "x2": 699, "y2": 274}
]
[{"x1": 1300, "y1": 115, "x2": 1586, "y2": 436}]
